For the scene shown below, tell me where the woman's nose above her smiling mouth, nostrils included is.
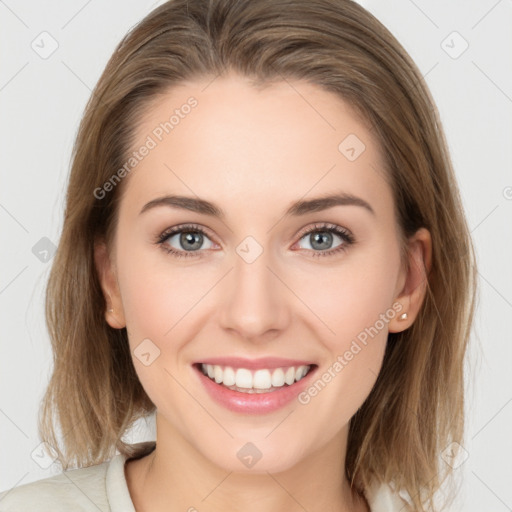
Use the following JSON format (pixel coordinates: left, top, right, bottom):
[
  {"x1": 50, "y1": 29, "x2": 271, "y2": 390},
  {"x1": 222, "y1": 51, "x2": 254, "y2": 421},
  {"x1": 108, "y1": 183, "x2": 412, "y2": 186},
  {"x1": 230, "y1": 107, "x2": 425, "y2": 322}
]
[{"x1": 220, "y1": 245, "x2": 293, "y2": 342}]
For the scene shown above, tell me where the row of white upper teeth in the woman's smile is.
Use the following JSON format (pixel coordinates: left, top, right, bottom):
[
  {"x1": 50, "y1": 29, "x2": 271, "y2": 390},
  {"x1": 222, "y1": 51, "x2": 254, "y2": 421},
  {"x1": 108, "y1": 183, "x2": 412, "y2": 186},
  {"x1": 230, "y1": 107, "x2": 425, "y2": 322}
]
[{"x1": 201, "y1": 364, "x2": 311, "y2": 390}]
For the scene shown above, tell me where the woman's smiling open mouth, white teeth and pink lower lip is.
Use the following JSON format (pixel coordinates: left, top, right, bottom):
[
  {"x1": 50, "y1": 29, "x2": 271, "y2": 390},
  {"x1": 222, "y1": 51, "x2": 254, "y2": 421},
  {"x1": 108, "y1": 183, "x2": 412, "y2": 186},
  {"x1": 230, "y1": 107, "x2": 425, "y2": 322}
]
[{"x1": 192, "y1": 360, "x2": 318, "y2": 414}]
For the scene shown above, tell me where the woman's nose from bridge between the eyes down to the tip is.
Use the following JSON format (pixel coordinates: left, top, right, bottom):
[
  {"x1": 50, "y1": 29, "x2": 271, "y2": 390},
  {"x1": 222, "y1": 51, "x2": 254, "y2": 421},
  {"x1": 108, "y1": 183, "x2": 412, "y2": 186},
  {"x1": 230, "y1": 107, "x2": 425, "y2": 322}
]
[{"x1": 221, "y1": 237, "x2": 289, "y2": 339}]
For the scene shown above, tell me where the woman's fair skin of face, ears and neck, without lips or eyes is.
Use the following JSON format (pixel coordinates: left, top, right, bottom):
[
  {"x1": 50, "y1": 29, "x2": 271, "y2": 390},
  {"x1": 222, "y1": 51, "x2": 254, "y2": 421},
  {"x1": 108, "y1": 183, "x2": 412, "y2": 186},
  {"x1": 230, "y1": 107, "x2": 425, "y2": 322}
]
[{"x1": 95, "y1": 74, "x2": 431, "y2": 512}]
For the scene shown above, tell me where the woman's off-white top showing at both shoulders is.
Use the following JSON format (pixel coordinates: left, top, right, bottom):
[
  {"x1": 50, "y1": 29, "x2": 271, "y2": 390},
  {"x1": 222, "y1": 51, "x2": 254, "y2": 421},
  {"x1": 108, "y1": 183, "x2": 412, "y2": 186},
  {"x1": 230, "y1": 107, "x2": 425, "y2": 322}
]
[{"x1": 0, "y1": 441, "x2": 410, "y2": 512}]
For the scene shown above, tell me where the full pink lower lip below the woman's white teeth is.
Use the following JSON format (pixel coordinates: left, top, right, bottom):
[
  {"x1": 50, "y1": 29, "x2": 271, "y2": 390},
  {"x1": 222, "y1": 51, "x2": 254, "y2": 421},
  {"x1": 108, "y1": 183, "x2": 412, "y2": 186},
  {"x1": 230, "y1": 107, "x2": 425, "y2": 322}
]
[{"x1": 194, "y1": 365, "x2": 317, "y2": 414}]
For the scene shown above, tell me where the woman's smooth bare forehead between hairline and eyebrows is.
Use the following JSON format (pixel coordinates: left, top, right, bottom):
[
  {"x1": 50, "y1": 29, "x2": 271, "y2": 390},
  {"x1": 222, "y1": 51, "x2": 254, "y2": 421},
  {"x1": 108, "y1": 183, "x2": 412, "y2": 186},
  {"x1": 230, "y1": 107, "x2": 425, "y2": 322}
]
[{"x1": 121, "y1": 75, "x2": 391, "y2": 217}]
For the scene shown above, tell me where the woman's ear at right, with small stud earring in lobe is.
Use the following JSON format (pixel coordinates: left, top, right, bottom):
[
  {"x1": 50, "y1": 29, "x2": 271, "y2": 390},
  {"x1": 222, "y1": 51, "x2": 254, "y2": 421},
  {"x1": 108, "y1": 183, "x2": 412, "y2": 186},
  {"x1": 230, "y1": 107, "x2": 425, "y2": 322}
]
[{"x1": 388, "y1": 228, "x2": 432, "y2": 332}]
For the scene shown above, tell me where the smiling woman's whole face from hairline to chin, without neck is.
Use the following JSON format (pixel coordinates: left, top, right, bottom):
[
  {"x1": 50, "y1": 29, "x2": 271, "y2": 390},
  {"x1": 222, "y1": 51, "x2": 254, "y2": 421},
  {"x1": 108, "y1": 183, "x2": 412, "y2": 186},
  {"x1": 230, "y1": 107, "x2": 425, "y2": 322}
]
[{"x1": 97, "y1": 71, "x2": 424, "y2": 472}]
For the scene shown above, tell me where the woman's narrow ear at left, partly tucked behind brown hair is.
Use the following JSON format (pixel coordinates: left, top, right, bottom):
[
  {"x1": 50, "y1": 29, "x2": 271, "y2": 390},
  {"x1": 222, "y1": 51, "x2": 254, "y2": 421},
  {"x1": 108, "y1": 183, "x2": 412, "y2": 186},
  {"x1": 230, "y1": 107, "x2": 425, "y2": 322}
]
[{"x1": 94, "y1": 240, "x2": 126, "y2": 329}]
